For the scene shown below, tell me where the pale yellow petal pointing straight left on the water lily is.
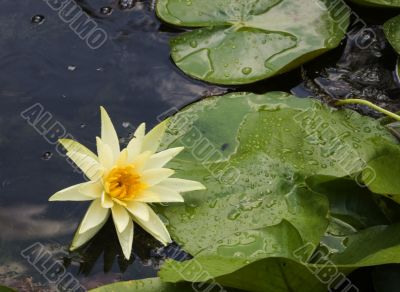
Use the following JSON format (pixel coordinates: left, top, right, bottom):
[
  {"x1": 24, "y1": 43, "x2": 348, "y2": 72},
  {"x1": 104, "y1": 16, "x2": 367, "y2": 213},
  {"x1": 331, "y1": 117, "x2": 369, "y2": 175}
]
[{"x1": 49, "y1": 182, "x2": 102, "y2": 201}]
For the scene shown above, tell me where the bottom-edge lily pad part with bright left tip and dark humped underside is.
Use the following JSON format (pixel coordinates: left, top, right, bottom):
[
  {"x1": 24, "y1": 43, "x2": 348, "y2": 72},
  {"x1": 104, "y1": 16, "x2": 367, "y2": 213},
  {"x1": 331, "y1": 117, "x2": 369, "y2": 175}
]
[{"x1": 161, "y1": 256, "x2": 327, "y2": 292}]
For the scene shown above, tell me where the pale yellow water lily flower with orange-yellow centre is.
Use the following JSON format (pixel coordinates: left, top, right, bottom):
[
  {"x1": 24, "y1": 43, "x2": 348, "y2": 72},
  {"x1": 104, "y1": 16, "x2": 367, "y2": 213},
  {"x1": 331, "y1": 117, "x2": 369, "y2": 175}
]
[{"x1": 49, "y1": 107, "x2": 205, "y2": 259}]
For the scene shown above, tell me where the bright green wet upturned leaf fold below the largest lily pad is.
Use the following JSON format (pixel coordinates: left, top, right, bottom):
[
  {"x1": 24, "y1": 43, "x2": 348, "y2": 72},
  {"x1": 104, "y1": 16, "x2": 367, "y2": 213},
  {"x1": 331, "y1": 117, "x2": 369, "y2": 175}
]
[{"x1": 160, "y1": 221, "x2": 303, "y2": 282}]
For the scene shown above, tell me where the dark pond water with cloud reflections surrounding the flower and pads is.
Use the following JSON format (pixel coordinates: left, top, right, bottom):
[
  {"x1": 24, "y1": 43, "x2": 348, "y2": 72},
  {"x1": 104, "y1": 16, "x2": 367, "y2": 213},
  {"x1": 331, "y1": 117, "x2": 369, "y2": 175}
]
[{"x1": 0, "y1": 0, "x2": 399, "y2": 291}]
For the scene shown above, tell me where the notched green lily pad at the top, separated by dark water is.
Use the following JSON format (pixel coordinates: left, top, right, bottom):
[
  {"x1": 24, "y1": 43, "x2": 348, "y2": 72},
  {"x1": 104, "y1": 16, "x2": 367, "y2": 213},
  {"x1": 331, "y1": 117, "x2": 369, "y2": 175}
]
[{"x1": 157, "y1": 0, "x2": 350, "y2": 84}]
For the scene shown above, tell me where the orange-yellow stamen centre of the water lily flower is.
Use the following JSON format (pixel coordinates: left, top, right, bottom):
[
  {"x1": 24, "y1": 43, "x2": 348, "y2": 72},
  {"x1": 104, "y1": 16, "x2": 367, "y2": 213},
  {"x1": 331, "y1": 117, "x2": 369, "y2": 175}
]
[{"x1": 104, "y1": 165, "x2": 147, "y2": 201}]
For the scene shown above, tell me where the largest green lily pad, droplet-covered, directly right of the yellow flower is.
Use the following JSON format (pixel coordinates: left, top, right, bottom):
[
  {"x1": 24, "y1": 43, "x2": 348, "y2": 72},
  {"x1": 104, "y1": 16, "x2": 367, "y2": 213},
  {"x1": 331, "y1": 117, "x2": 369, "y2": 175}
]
[{"x1": 160, "y1": 92, "x2": 400, "y2": 255}]
